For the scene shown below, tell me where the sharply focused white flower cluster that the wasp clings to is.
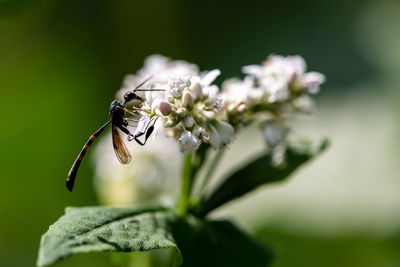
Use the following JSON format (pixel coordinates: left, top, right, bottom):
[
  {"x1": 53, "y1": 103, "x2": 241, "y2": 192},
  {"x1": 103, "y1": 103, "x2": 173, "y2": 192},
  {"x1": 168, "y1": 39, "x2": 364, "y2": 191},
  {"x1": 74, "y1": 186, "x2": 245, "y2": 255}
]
[{"x1": 120, "y1": 55, "x2": 234, "y2": 154}]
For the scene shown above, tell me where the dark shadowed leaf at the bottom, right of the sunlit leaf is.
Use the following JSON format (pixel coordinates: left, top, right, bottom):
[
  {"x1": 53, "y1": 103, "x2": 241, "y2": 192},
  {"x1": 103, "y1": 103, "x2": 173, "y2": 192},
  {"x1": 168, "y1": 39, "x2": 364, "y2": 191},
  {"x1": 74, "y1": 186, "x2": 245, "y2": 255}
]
[{"x1": 172, "y1": 217, "x2": 274, "y2": 267}]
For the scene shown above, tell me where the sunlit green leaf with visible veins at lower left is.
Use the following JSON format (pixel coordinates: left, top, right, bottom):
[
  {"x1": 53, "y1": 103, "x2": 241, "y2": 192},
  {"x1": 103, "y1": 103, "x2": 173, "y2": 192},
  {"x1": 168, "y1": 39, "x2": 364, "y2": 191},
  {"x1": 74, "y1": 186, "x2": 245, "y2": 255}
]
[{"x1": 37, "y1": 207, "x2": 178, "y2": 266}]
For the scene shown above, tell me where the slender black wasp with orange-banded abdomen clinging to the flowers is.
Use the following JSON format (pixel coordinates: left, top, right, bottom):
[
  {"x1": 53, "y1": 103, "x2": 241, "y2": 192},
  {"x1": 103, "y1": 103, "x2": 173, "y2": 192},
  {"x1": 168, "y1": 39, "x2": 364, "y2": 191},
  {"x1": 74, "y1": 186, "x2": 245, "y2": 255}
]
[{"x1": 66, "y1": 77, "x2": 164, "y2": 192}]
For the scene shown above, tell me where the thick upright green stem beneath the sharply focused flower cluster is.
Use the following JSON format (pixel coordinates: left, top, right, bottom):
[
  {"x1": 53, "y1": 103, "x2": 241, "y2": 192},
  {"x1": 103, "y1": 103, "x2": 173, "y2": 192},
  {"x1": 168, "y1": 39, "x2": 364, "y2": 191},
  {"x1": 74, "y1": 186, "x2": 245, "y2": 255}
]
[{"x1": 178, "y1": 153, "x2": 193, "y2": 215}]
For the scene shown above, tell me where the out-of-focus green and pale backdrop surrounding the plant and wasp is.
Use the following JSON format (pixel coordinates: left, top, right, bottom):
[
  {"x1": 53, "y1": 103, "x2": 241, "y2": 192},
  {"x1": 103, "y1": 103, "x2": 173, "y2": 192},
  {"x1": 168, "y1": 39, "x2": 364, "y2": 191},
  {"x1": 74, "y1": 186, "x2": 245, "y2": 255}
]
[{"x1": 0, "y1": 0, "x2": 400, "y2": 266}]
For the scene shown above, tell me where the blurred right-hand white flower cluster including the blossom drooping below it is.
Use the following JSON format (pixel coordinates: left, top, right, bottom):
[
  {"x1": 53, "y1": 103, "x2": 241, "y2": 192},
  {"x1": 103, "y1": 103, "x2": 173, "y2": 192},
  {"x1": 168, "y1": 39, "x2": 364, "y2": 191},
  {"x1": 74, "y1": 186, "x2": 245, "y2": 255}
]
[{"x1": 222, "y1": 55, "x2": 325, "y2": 147}]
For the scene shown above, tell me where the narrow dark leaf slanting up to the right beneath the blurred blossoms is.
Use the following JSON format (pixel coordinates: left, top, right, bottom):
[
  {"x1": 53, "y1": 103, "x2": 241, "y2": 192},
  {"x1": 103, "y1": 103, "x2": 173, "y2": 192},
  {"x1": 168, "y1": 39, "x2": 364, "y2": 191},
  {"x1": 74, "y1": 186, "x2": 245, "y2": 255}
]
[{"x1": 199, "y1": 140, "x2": 328, "y2": 216}]
